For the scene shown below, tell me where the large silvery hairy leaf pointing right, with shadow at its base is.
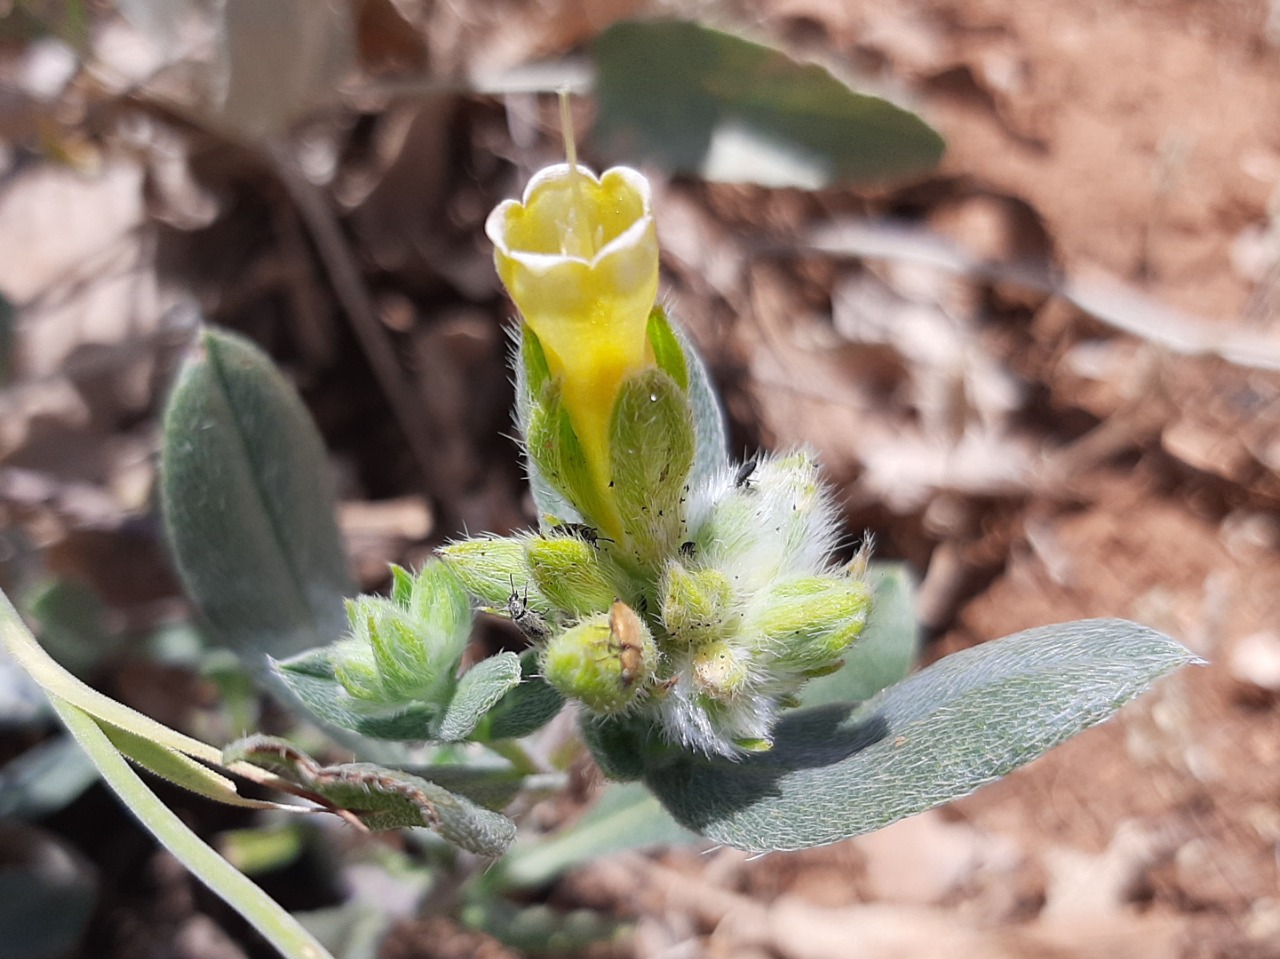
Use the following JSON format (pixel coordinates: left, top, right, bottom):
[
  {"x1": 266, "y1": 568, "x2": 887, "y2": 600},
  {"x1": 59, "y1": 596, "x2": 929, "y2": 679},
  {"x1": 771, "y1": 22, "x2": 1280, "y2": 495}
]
[{"x1": 645, "y1": 620, "x2": 1196, "y2": 850}]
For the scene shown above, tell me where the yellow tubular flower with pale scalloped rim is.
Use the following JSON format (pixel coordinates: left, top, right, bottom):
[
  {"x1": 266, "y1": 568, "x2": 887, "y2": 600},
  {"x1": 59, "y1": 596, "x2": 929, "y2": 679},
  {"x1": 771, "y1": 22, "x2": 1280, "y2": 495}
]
[{"x1": 485, "y1": 164, "x2": 658, "y2": 539}]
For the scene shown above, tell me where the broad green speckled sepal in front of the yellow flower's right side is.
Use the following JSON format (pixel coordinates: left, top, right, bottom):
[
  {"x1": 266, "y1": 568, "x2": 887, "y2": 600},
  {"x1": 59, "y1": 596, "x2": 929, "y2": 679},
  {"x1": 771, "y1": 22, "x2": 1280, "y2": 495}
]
[{"x1": 609, "y1": 369, "x2": 694, "y2": 568}]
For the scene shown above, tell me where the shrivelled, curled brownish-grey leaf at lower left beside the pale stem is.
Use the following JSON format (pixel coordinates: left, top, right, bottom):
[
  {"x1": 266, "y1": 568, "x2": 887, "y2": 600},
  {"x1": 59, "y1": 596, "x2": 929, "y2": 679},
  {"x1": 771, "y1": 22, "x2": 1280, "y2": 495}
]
[{"x1": 223, "y1": 736, "x2": 516, "y2": 858}]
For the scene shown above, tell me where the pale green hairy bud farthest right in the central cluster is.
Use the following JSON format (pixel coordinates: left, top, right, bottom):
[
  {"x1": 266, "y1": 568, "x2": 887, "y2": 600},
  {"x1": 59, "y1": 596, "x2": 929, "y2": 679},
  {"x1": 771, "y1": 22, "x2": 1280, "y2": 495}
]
[{"x1": 746, "y1": 576, "x2": 870, "y2": 675}]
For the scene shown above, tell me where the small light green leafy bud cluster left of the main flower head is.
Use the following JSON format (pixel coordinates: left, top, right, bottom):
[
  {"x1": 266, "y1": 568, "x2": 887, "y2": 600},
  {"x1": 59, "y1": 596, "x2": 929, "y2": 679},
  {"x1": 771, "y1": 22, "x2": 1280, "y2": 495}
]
[{"x1": 330, "y1": 561, "x2": 471, "y2": 708}]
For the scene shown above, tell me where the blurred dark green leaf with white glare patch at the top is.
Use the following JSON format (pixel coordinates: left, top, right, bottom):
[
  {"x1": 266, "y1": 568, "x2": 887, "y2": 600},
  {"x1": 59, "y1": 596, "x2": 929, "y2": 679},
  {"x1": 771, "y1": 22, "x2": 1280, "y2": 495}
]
[{"x1": 591, "y1": 20, "x2": 943, "y2": 189}]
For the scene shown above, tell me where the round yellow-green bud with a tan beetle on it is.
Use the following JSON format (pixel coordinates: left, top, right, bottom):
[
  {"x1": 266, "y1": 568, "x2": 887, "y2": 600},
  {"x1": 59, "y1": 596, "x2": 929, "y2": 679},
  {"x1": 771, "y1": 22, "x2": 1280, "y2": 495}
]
[{"x1": 543, "y1": 600, "x2": 658, "y2": 714}]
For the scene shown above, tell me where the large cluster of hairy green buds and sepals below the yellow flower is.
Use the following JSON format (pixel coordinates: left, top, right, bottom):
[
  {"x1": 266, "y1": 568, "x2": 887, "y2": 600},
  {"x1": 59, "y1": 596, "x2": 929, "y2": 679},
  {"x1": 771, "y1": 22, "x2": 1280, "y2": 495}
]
[{"x1": 440, "y1": 309, "x2": 870, "y2": 757}]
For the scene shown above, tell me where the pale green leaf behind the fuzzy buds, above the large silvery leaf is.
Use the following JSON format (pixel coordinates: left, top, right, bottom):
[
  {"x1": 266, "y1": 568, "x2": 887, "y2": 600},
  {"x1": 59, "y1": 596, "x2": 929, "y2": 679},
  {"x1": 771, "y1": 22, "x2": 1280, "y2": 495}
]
[{"x1": 800, "y1": 563, "x2": 920, "y2": 707}]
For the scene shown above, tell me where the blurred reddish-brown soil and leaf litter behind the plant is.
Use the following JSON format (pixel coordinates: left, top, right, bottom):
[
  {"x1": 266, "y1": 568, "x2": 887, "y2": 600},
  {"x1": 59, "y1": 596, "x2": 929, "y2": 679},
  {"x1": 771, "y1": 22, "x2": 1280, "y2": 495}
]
[{"x1": 0, "y1": 0, "x2": 1280, "y2": 959}]
